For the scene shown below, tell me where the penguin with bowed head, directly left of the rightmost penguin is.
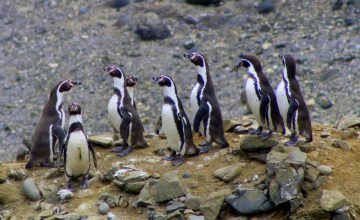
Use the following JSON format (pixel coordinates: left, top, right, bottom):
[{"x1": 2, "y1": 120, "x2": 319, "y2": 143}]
[{"x1": 237, "y1": 55, "x2": 285, "y2": 139}]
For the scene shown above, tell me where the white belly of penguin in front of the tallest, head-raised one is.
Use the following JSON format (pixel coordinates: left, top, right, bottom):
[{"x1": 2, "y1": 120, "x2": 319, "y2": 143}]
[{"x1": 161, "y1": 104, "x2": 181, "y2": 152}]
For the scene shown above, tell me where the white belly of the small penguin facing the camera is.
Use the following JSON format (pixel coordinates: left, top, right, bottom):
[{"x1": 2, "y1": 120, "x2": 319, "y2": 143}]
[{"x1": 65, "y1": 131, "x2": 90, "y2": 177}]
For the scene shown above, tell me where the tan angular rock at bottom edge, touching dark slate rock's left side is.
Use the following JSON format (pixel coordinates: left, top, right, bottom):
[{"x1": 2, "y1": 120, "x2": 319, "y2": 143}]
[{"x1": 200, "y1": 189, "x2": 231, "y2": 220}]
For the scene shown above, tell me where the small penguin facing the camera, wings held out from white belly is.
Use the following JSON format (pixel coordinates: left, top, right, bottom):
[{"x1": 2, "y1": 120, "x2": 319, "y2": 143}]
[{"x1": 62, "y1": 103, "x2": 97, "y2": 191}]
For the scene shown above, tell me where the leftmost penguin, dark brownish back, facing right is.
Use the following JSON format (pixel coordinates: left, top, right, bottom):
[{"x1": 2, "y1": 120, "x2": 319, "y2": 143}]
[{"x1": 25, "y1": 79, "x2": 81, "y2": 169}]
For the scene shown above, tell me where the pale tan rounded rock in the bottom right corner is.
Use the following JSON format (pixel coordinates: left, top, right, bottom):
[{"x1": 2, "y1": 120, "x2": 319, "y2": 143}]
[{"x1": 320, "y1": 190, "x2": 346, "y2": 212}]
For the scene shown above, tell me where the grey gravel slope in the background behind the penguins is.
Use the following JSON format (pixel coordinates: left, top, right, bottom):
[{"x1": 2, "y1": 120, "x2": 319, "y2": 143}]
[{"x1": 0, "y1": 0, "x2": 360, "y2": 161}]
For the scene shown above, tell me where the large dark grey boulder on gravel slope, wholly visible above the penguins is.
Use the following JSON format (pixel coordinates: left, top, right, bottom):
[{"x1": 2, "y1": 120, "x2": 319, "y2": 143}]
[{"x1": 135, "y1": 13, "x2": 171, "y2": 41}]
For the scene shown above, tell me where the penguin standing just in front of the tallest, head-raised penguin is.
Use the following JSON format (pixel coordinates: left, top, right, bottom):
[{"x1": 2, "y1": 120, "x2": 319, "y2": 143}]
[{"x1": 152, "y1": 75, "x2": 199, "y2": 166}]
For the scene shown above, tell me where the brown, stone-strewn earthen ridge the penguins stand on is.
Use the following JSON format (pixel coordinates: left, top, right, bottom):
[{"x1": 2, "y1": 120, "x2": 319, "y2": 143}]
[{"x1": 0, "y1": 117, "x2": 360, "y2": 220}]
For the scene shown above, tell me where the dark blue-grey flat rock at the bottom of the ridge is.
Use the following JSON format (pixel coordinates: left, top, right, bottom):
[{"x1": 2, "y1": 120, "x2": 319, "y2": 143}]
[{"x1": 225, "y1": 189, "x2": 275, "y2": 214}]
